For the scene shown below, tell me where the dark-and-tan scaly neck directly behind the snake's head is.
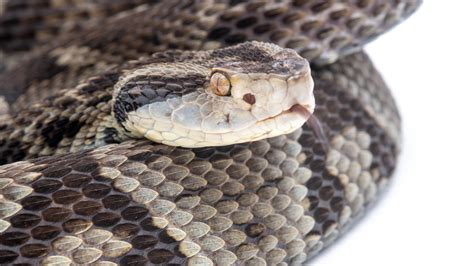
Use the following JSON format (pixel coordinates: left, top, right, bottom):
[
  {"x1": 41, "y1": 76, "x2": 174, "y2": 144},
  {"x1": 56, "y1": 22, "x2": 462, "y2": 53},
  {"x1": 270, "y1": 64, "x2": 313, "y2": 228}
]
[{"x1": 0, "y1": 82, "x2": 129, "y2": 164}]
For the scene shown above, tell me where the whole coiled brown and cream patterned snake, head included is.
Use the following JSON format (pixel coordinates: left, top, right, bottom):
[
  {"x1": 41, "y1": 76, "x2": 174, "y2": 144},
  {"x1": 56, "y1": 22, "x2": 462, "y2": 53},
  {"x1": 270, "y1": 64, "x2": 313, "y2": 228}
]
[{"x1": 0, "y1": 0, "x2": 421, "y2": 265}]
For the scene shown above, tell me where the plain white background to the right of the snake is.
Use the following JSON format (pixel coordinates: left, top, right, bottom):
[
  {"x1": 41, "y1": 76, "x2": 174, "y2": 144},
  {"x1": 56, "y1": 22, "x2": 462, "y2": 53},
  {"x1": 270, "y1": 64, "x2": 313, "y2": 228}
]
[{"x1": 313, "y1": 0, "x2": 474, "y2": 266}]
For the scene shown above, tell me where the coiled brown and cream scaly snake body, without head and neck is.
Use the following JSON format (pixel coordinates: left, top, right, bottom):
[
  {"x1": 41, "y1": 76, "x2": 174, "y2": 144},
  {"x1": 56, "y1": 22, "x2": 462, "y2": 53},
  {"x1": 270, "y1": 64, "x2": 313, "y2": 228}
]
[{"x1": 0, "y1": 0, "x2": 419, "y2": 265}]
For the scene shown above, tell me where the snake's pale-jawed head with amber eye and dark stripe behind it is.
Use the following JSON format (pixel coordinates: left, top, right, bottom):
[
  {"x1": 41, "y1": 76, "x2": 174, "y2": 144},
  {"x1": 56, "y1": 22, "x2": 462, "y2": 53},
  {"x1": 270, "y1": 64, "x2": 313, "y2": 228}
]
[{"x1": 114, "y1": 42, "x2": 315, "y2": 147}]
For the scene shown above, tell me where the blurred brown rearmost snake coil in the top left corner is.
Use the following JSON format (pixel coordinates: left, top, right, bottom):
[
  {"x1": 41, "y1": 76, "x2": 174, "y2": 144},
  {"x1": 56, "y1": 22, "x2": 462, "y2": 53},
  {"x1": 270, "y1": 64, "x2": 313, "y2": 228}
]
[{"x1": 0, "y1": 0, "x2": 153, "y2": 52}]
